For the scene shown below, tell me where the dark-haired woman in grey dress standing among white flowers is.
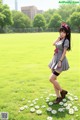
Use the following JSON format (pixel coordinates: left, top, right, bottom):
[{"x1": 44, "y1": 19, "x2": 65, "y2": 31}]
[{"x1": 48, "y1": 23, "x2": 71, "y2": 103}]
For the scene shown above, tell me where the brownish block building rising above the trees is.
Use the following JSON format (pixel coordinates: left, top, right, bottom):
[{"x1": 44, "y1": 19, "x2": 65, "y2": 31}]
[{"x1": 21, "y1": 6, "x2": 43, "y2": 20}]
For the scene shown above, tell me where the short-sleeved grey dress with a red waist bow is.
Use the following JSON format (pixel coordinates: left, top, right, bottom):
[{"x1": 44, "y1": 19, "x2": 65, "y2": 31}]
[{"x1": 48, "y1": 39, "x2": 70, "y2": 72}]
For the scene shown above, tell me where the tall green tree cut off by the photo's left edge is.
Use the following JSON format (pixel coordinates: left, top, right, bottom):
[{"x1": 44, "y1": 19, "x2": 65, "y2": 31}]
[{"x1": 0, "y1": 4, "x2": 12, "y2": 32}]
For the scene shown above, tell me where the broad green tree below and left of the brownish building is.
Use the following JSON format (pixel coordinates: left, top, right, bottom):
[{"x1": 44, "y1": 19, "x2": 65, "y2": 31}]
[{"x1": 12, "y1": 10, "x2": 31, "y2": 28}]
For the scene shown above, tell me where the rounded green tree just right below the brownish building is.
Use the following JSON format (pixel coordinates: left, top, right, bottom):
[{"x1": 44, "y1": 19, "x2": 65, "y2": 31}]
[{"x1": 33, "y1": 14, "x2": 46, "y2": 28}]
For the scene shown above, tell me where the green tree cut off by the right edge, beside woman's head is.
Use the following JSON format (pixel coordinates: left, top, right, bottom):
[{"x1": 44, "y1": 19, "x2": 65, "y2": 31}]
[{"x1": 69, "y1": 12, "x2": 80, "y2": 32}]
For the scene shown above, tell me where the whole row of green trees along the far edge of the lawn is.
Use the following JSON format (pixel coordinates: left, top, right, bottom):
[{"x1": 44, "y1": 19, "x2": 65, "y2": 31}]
[{"x1": 0, "y1": 2, "x2": 80, "y2": 33}]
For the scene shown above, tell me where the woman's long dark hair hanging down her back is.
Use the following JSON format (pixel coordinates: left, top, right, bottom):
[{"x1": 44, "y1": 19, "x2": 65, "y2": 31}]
[{"x1": 59, "y1": 26, "x2": 71, "y2": 51}]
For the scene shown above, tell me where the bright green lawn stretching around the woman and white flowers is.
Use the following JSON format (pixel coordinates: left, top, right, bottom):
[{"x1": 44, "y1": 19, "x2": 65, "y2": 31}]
[{"x1": 0, "y1": 33, "x2": 80, "y2": 120}]
